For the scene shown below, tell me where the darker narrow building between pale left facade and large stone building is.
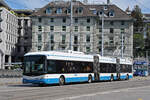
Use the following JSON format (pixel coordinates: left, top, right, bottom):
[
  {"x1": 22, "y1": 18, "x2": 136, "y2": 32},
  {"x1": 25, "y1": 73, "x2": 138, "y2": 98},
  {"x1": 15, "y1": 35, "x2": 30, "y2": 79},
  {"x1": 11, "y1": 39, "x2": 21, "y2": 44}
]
[{"x1": 14, "y1": 10, "x2": 33, "y2": 62}]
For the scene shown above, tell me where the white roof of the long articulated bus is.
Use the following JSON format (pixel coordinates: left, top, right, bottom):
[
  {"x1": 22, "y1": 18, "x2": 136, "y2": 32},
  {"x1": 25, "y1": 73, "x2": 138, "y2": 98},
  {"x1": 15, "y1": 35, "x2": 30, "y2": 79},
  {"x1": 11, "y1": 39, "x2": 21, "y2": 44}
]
[{"x1": 25, "y1": 50, "x2": 132, "y2": 64}]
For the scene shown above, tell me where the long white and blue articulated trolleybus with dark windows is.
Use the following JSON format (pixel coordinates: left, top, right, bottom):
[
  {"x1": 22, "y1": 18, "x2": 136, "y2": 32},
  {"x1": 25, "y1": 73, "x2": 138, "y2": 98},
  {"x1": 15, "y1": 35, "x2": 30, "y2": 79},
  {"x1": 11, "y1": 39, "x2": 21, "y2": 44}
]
[{"x1": 23, "y1": 50, "x2": 133, "y2": 85}]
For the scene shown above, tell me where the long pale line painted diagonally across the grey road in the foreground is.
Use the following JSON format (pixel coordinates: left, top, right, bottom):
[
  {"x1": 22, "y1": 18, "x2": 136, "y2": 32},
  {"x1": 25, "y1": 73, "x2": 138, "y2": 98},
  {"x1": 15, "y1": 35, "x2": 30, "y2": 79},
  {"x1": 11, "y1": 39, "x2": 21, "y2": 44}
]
[{"x1": 55, "y1": 86, "x2": 150, "y2": 100}]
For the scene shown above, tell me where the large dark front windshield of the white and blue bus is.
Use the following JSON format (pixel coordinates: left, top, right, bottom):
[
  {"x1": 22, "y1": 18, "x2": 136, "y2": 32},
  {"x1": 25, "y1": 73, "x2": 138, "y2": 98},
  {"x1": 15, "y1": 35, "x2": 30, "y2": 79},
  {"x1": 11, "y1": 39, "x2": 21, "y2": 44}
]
[{"x1": 24, "y1": 55, "x2": 45, "y2": 75}]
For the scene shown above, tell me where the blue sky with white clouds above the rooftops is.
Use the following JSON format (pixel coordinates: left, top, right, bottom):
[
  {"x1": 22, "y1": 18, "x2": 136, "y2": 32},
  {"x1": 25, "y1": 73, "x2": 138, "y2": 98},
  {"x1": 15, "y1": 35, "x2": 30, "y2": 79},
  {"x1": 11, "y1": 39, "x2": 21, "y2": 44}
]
[{"x1": 5, "y1": 0, "x2": 150, "y2": 13}]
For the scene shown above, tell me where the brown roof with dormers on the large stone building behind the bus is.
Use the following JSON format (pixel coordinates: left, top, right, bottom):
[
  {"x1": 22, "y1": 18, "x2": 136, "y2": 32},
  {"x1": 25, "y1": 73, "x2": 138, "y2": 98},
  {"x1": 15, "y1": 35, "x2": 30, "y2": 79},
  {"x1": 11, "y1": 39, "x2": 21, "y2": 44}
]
[{"x1": 32, "y1": 1, "x2": 132, "y2": 20}]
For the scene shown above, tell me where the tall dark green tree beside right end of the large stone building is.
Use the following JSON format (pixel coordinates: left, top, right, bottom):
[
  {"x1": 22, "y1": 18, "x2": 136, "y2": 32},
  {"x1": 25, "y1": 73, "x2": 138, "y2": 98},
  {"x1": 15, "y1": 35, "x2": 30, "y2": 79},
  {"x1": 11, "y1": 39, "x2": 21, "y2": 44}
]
[{"x1": 131, "y1": 5, "x2": 145, "y2": 57}]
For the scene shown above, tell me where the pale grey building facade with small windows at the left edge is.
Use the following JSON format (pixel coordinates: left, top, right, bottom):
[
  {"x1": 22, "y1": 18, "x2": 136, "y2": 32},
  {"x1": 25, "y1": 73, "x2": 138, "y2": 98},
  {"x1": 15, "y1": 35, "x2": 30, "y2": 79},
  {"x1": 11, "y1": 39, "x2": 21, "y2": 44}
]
[{"x1": 0, "y1": 7, "x2": 18, "y2": 69}]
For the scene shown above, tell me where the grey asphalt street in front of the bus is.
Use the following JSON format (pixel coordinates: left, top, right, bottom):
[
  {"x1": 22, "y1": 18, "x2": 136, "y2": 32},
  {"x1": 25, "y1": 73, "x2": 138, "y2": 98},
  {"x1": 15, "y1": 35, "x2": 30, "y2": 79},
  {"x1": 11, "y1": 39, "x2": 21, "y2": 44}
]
[{"x1": 0, "y1": 78, "x2": 150, "y2": 100}]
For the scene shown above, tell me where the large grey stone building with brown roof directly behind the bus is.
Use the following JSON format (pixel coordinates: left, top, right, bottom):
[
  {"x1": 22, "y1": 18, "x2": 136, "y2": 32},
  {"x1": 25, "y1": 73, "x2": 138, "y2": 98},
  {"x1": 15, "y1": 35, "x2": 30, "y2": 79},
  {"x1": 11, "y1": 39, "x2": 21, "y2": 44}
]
[{"x1": 31, "y1": 0, "x2": 133, "y2": 57}]
